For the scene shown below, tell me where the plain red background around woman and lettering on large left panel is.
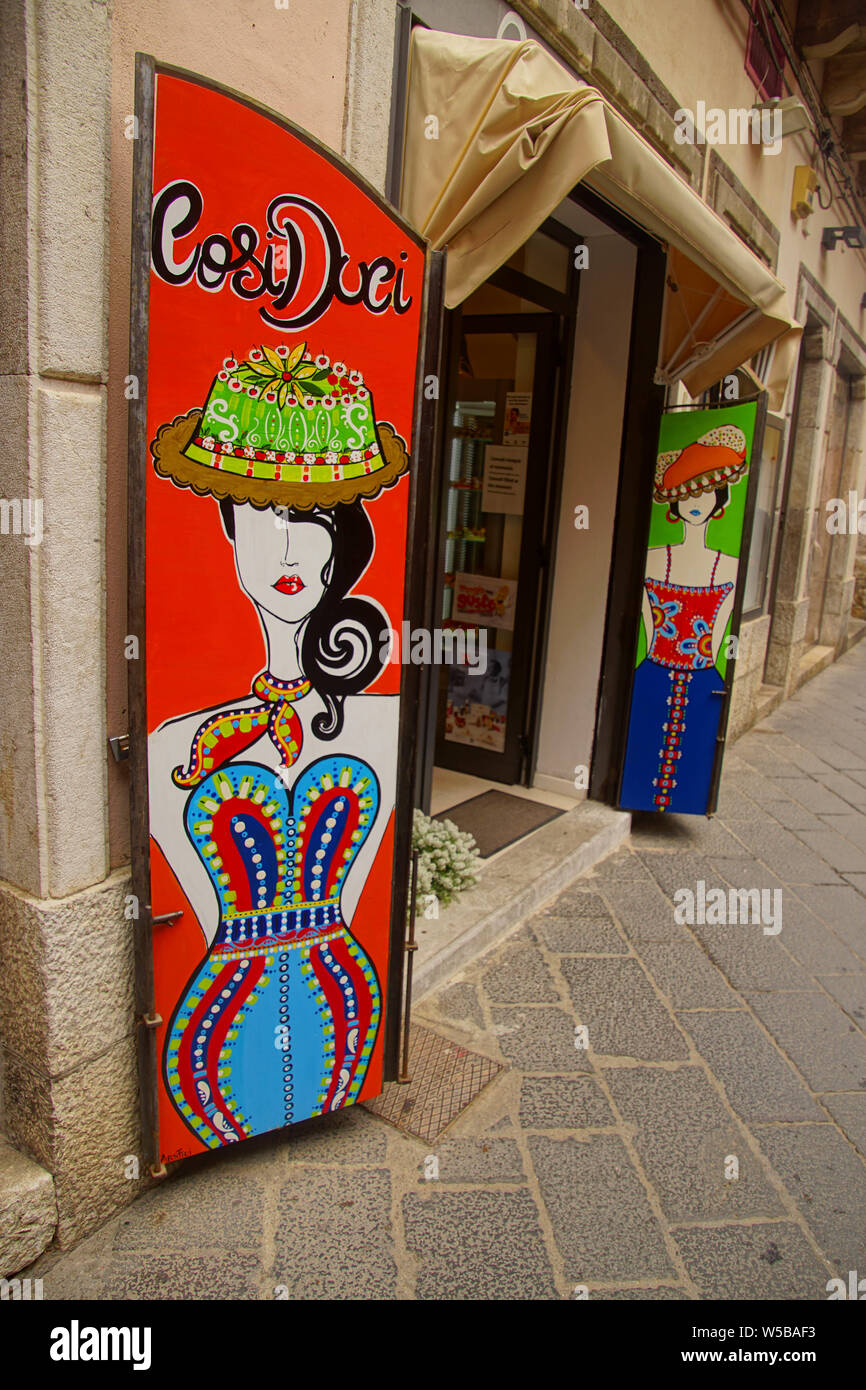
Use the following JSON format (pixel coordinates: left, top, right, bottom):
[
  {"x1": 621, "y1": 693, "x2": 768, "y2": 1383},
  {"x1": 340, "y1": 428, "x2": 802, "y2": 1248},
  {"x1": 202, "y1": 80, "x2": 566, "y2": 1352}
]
[{"x1": 146, "y1": 74, "x2": 424, "y2": 1162}]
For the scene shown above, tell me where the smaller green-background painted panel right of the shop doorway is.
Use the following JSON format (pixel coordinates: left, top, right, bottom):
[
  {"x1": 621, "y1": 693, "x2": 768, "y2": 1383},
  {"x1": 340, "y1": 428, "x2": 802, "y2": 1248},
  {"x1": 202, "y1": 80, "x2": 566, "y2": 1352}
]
[{"x1": 620, "y1": 402, "x2": 758, "y2": 815}]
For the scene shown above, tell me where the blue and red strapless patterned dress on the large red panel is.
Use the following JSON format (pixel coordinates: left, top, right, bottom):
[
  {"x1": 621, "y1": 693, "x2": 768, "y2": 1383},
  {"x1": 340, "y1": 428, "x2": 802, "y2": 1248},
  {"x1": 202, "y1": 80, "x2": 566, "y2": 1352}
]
[{"x1": 164, "y1": 750, "x2": 381, "y2": 1148}]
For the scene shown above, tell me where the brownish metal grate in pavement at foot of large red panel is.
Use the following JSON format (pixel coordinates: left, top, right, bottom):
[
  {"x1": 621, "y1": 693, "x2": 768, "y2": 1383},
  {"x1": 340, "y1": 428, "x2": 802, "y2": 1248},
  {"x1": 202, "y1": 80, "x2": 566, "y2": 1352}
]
[{"x1": 364, "y1": 1023, "x2": 505, "y2": 1144}]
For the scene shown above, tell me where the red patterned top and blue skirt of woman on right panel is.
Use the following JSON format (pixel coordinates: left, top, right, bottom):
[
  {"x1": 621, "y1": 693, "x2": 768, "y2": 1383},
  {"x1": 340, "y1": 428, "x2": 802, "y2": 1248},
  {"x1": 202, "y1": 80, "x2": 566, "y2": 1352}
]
[{"x1": 620, "y1": 546, "x2": 734, "y2": 815}]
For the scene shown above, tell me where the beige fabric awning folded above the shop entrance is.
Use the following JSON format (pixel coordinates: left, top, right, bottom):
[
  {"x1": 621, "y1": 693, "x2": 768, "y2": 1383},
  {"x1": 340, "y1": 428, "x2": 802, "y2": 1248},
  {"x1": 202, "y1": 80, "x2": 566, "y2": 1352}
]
[{"x1": 402, "y1": 26, "x2": 801, "y2": 409}]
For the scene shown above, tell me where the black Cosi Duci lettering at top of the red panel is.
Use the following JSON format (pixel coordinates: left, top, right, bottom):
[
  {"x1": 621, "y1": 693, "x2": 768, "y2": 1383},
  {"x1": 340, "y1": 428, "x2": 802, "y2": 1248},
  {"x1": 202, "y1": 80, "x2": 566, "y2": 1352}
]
[{"x1": 150, "y1": 179, "x2": 411, "y2": 328}]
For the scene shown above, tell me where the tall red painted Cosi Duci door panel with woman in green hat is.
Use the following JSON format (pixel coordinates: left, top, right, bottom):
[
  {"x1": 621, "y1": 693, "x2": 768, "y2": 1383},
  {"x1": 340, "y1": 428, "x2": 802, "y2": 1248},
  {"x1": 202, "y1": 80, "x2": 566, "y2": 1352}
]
[{"x1": 139, "y1": 68, "x2": 425, "y2": 1162}]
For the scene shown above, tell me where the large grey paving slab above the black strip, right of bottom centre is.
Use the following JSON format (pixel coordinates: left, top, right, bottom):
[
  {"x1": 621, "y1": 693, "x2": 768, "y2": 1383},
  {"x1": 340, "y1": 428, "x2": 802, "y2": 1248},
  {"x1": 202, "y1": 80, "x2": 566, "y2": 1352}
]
[{"x1": 528, "y1": 1134, "x2": 676, "y2": 1283}]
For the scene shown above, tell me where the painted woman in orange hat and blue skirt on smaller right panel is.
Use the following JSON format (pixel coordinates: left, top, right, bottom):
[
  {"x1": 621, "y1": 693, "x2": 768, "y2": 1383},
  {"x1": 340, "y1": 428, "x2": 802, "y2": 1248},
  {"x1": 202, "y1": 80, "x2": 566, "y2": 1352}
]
[{"x1": 620, "y1": 424, "x2": 746, "y2": 813}]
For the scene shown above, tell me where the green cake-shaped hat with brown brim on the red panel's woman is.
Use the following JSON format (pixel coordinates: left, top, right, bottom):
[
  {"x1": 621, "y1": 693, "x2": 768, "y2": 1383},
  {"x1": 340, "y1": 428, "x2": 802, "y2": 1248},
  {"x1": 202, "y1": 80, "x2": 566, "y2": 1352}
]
[{"x1": 150, "y1": 342, "x2": 409, "y2": 510}]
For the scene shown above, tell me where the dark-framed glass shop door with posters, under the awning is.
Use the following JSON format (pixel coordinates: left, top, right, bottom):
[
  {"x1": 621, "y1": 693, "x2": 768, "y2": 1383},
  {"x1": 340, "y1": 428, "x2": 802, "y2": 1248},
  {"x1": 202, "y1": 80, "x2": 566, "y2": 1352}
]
[{"x1": 436, "y1": 314, "x2": 555, "y2": 783}]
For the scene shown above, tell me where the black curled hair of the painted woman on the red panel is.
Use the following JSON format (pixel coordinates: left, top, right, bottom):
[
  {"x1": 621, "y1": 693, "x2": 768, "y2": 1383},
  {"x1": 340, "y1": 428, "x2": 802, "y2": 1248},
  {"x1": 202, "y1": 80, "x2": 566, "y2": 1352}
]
[{"x1": 220, "y1": 498, "x2": 384, "y2": 739}]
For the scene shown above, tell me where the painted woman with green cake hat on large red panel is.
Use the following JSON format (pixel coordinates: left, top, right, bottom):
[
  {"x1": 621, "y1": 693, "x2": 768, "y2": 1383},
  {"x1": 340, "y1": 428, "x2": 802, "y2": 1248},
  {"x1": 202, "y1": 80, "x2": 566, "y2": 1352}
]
[{"x1": 149, "y1": 342, "x2": 409, "y2": 1148}]
